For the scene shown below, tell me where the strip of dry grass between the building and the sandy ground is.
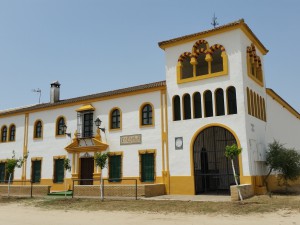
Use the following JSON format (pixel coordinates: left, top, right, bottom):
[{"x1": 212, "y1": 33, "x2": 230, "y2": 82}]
[{"x1": 0, "y1": 195, "x2": 300, "y2": 215}]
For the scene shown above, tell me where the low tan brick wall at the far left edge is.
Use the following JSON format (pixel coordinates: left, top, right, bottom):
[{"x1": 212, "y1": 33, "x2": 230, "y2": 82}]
[{"x1": 0, "y1": 180, "x2": 50, "y2": 198}]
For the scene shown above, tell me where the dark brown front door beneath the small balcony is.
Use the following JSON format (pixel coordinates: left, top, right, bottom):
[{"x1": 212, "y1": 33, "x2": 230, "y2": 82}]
[{"x1": 80, "y1": 158, "x2": 94, "y2": 185}]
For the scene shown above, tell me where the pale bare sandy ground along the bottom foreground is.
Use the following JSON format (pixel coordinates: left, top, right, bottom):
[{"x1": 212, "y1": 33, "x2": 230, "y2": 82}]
[{"x1": 0, "y1": 203, "x2": 300, "y2": 225}]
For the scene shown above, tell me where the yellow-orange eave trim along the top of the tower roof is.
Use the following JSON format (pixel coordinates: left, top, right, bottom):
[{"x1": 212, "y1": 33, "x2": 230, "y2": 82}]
[{"x1": 159, "y1": 22, "x2": 268, "y2": 55}]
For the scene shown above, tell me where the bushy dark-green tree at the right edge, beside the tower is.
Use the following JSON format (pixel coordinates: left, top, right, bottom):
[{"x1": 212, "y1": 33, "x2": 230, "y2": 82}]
[{"x1": 264, "y1": 140, "x2": 300, "y2": 192}]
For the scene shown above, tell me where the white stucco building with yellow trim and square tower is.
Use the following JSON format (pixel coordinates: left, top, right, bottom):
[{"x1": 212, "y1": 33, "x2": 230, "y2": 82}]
[{"x1": 0, "y1": 20, "x2": 300, "y2": 195}]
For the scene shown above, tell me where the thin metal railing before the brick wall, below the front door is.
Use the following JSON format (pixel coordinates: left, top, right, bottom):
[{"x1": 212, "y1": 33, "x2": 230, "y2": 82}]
[{"x1": 72, "y1": 178, "x2": 138, "y2": 200}]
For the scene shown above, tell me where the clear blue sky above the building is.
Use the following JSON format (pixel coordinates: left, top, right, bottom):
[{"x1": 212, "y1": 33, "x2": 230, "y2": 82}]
[{"x1": 0, "y1": 0, "x2": 300, "y2": 111}]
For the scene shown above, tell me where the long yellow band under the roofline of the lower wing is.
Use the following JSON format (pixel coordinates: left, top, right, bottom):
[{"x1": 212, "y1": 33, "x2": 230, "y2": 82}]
[{"x1": 1, "y1": 86, "x2": 166, "y2": 118}]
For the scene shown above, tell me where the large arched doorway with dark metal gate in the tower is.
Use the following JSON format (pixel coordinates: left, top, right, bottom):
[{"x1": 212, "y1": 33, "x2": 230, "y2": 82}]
[{"x1": 193, "y1": 126, "x2": 239, "y2": 194}]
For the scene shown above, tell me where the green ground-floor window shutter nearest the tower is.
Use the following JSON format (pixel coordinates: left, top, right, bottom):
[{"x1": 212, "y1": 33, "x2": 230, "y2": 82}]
[{"x1": 141, "y1": 153, "x2": 154, "y2": 182}]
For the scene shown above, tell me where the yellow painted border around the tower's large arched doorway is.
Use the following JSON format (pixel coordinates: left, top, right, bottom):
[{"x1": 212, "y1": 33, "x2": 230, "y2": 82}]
[{"x1": 190, "y1": 123, "x2": 244, "y2": 194}]
